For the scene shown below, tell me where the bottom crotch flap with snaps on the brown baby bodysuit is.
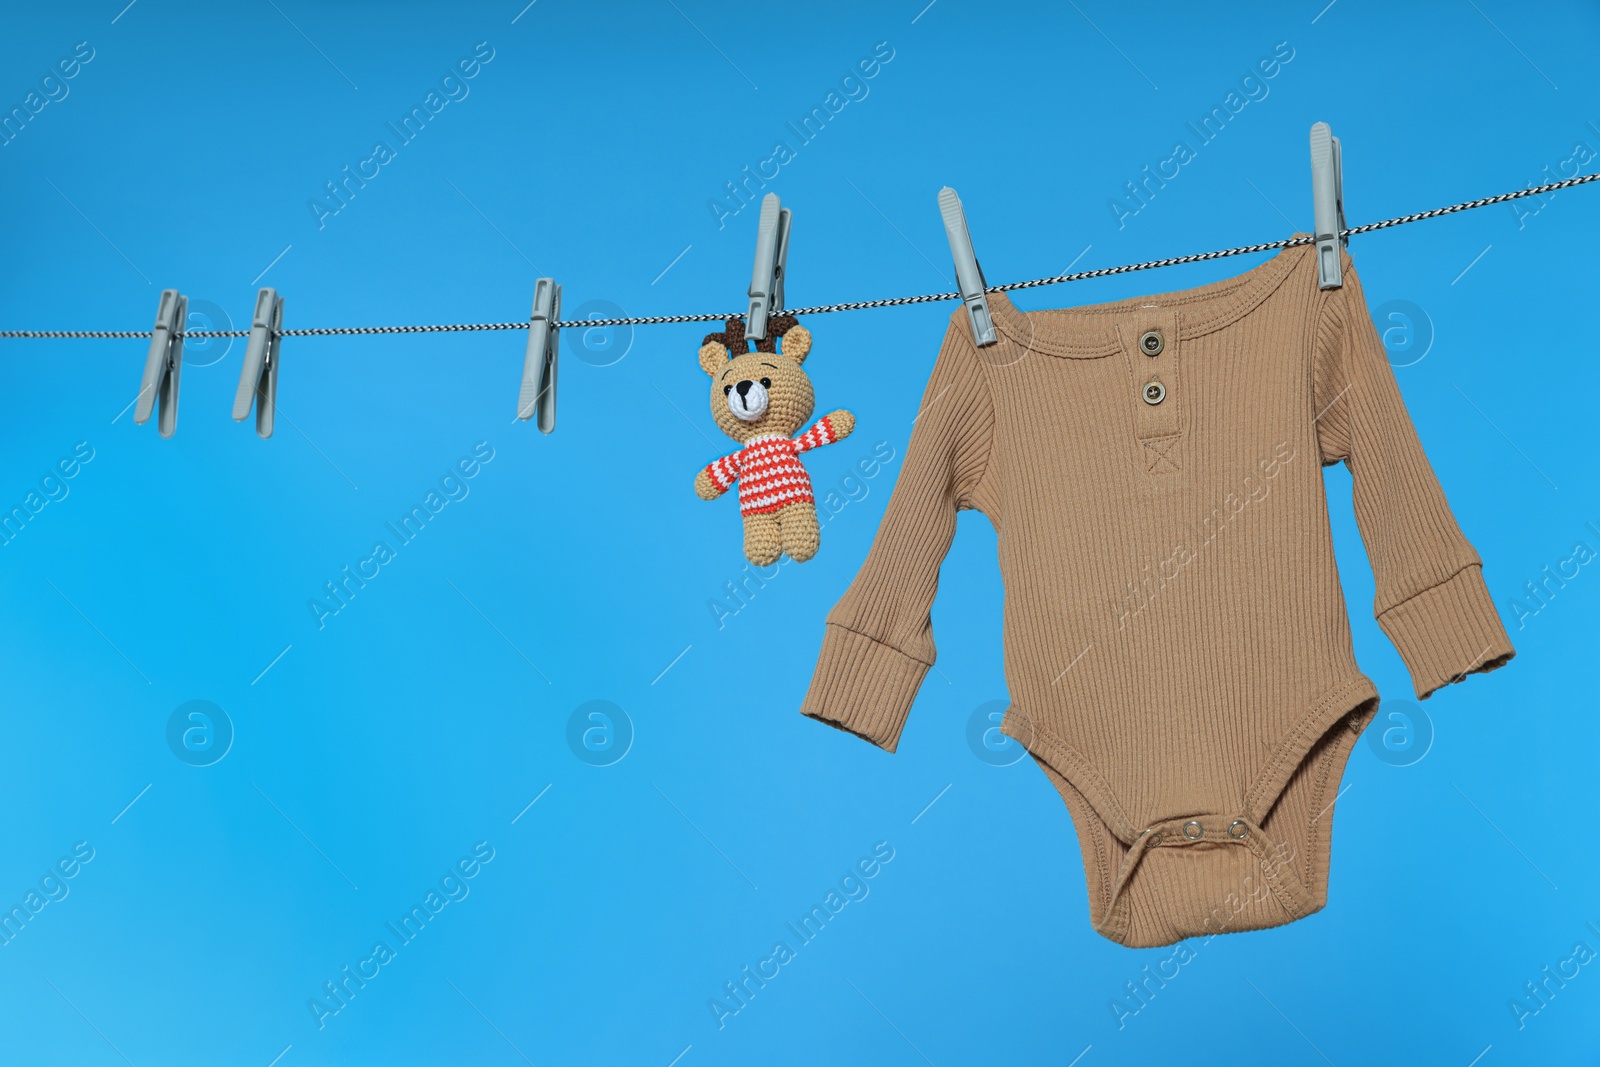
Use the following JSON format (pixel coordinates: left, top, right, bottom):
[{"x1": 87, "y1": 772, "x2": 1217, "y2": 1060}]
[{"x1": 1096, "y1": 813, "x2": 1317, "y2": 947}]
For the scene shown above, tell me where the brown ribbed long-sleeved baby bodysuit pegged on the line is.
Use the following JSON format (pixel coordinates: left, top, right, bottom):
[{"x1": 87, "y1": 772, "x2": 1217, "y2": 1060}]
[{"x1": 802, "y1": 245, "x2": 1514, "y2": 947}]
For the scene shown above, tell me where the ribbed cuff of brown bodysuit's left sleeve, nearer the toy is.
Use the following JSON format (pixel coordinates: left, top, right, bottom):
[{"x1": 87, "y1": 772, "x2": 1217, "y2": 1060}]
[{"x1": 800, "y1": 624, "x2": 928, "y2": 752}]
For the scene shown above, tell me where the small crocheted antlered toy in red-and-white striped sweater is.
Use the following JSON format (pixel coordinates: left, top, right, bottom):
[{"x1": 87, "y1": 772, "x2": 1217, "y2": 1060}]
[{"x1": 694, "y1": 315, "x2": 856, "y2": 566}]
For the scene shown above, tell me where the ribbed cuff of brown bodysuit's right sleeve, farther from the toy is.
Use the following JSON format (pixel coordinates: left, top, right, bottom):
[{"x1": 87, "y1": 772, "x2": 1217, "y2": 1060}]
[{"x1": 1378, "y1": 563, "x2": 1517, "y2": 701}]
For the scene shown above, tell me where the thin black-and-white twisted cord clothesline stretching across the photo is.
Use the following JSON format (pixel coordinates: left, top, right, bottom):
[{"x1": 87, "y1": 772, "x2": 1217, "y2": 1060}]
[{"x1": 0, "y1": 171, "x2": 1600, "y2": 341}]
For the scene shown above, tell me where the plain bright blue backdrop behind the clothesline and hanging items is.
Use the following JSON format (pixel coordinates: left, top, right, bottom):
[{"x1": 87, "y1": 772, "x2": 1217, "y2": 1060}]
[{"x1": 0, "y1": 0, "x2": 1600, "y2": 1067}]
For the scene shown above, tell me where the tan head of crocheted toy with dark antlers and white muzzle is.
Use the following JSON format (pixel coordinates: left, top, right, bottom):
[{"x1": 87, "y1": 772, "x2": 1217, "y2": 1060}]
[{"x1": 699, "y1": 315, "x2": 816, "y2": 445}]
